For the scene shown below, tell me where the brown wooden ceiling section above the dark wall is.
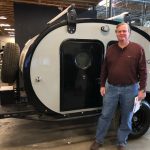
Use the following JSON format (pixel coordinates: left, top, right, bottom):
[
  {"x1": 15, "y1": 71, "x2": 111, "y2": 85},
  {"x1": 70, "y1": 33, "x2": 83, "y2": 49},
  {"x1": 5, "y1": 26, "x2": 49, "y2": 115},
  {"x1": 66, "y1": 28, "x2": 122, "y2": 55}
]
[{"x1": 0, "y1": 0, "x2": 101, "y2": 35}]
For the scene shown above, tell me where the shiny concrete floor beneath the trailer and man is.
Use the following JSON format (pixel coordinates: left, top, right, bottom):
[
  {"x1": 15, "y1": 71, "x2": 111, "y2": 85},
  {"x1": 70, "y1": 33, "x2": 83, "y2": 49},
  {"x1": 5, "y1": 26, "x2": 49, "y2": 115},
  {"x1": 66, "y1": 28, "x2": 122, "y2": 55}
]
[{"x1": 0, "y1": 118, "x2": 150, "y2": 150}]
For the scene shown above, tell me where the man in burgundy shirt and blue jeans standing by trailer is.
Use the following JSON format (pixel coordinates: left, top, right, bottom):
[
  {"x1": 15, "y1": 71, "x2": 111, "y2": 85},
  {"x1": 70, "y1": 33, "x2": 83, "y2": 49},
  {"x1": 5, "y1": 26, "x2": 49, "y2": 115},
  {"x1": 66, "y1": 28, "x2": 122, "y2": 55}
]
[{"x1": 91, "y1": 23, "x2": 147, "y2": 150}]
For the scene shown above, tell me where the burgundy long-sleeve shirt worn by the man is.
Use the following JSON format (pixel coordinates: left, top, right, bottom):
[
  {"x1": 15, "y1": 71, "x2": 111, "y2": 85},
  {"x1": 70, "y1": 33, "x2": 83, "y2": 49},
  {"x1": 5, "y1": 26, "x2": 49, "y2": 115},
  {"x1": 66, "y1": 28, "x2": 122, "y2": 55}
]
[{"x1": 101, "y1": 42, "x2": 147, "y2": 89}]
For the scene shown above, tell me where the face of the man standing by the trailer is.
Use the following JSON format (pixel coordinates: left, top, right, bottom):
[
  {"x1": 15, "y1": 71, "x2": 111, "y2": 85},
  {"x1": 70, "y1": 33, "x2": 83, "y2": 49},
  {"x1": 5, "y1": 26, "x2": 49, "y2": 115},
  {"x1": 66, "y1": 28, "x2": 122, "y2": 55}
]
[{"x1": 116, "y1": 24, "x2": 130, "y2": 42}]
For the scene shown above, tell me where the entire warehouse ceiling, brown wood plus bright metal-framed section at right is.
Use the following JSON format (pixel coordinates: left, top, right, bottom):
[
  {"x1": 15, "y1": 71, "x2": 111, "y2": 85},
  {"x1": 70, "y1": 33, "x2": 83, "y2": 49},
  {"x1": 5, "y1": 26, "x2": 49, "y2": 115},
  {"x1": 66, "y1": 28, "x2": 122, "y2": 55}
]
[{"x1": 0, "y1": 0, "x2": 150, "y2": 35}]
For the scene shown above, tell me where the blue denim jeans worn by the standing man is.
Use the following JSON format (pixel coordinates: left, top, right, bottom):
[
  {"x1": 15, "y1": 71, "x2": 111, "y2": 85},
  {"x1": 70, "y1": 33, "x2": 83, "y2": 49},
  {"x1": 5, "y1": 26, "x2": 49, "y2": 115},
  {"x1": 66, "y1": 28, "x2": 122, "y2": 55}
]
[{"x1": 96, "y1": 83, "x2": 138, "y2": 146}]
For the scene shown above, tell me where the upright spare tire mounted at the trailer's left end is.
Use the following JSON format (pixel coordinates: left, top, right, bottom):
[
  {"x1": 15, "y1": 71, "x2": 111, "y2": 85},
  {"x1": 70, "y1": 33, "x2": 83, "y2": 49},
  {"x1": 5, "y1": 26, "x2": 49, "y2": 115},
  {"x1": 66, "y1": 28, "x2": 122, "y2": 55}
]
[{"x1": 1, "y1": 43, "x2": 20, "y2": 83}]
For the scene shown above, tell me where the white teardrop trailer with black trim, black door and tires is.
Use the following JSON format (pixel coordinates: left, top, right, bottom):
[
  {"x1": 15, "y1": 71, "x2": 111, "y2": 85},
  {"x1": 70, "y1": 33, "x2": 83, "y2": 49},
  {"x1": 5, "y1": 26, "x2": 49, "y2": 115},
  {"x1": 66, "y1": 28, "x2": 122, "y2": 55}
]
[{"x1": 0, "y1": 7, "x2": 150, "y2": 138}]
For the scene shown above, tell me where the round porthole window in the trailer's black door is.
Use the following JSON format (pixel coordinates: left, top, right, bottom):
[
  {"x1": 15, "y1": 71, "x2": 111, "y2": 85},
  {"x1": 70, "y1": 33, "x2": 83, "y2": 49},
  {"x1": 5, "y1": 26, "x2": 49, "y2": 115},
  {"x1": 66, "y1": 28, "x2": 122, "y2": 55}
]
[{"x1": 75, "y1": 52, "x2": 91, "y2": 70}]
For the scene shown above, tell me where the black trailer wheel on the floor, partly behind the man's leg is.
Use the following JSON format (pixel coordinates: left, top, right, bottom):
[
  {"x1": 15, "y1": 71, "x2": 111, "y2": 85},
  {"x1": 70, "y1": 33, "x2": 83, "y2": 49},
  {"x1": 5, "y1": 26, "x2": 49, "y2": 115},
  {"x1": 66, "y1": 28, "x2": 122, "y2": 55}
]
[{"x1": 129, "y1": 101, "x2": 150, "y2": 139}]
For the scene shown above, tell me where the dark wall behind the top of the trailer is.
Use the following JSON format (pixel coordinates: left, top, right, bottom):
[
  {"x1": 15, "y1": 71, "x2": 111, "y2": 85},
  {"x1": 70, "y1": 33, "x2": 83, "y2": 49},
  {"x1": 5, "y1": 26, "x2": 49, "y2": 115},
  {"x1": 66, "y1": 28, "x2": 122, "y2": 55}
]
[{"x1": 14, "y1": 3, "x2": 96, "y2": 49}]
